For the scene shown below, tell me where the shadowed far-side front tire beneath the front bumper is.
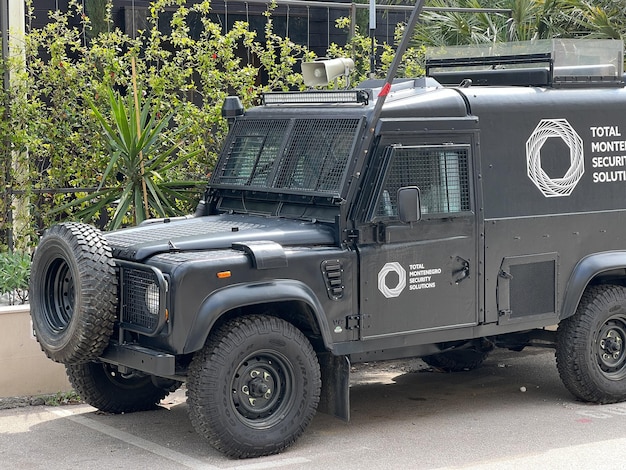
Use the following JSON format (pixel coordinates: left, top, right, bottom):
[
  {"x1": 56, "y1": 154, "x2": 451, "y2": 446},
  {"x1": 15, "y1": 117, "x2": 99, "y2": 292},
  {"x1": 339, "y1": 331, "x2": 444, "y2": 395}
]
[{"x1": 65, "y1": 362, "x2": 181, "y2": 413}]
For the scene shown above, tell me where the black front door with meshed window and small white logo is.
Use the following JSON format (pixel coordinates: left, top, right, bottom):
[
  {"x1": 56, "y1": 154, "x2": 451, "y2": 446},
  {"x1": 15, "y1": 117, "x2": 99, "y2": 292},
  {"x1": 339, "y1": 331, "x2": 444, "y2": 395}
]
[{"x1": 358, "y1": 140, "x2": 478, "y2": 339}]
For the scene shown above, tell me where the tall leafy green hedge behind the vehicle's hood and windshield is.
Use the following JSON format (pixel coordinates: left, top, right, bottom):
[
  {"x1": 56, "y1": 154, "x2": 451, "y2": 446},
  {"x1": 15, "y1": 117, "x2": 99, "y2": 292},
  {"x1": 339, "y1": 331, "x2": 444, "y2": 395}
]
[{"x1": 0, "y1": 0, "x2": 420, "y2": 242}]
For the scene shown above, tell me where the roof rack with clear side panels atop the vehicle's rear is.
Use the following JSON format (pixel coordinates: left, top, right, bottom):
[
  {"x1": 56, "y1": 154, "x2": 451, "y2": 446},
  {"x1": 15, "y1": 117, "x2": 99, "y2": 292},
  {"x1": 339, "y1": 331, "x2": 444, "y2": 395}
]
[{"x1": 426, "y1": 39, "x2": 624, "y2": 87}]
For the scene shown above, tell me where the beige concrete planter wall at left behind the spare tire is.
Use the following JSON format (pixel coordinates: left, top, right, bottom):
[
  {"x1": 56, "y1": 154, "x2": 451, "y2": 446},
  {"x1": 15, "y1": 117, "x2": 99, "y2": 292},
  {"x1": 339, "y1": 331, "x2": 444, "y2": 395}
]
[{"x1": 0, "y1": 305, "x2": 72, "y2": 397}]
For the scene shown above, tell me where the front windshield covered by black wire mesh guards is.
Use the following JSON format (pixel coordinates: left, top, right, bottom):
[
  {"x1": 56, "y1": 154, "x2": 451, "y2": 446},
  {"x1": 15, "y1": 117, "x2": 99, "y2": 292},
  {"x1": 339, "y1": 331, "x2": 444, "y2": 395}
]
[{"x1": 211, "y1": 118, "x2": 361, "y2": 197}]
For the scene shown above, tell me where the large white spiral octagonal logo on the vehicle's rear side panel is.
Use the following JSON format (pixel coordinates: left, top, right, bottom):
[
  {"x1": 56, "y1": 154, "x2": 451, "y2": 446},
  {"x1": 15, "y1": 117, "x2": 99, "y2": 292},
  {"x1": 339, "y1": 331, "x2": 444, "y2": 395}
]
[{"x1": 526, "y1": 119, "x2": 585, "y2": 197}]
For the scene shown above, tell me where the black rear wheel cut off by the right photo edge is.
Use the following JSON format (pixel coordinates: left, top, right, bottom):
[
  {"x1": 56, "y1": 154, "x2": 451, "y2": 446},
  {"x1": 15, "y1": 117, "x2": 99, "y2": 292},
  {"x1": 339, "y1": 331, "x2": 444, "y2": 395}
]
[{"x1": 556, "y1": 285, "x2": 626, "y2": 403}]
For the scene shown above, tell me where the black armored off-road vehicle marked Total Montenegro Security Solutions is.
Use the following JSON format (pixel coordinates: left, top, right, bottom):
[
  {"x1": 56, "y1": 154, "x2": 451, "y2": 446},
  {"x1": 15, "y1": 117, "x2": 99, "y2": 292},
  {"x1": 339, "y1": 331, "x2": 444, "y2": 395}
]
[{"x1": 31, "y1": 40, "x2": 626, "y2": 457}]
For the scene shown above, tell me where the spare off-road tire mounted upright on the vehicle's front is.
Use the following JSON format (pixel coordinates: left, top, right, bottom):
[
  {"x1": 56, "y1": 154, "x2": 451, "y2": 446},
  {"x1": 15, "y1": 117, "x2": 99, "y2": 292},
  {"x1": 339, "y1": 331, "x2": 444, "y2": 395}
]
[{"x1": 29, "y1": 223, "x2": 117, "y2": 364}]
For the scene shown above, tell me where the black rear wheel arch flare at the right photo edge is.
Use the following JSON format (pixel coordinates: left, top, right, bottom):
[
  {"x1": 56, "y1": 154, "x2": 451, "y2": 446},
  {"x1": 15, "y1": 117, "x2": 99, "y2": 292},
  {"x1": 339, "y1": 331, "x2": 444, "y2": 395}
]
[{"x1": 559, "y1": 251, "x2": 626, "y2": 320}]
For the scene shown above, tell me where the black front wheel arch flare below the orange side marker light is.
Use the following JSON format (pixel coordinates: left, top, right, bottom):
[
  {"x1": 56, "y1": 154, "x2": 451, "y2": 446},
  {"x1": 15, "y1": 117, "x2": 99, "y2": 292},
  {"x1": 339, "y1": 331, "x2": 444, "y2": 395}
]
[{"x1": 184, "y1": 279, "x2": 332, "y2": 353}]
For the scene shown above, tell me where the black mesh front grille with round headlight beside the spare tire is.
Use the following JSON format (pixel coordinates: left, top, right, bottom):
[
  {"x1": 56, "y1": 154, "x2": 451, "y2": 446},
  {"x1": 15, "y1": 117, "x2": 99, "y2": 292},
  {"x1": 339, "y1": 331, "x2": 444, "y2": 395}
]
[{"x1": 120, "y1": 265, "x2": 165, "y2": 334}]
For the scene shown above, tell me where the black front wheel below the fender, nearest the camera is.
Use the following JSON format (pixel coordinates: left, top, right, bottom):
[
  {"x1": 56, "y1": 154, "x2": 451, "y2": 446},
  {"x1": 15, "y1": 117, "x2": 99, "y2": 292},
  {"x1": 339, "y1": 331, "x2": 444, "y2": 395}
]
[{"x1": 187, "y1": 315, "x2": 321, "y2": 458}]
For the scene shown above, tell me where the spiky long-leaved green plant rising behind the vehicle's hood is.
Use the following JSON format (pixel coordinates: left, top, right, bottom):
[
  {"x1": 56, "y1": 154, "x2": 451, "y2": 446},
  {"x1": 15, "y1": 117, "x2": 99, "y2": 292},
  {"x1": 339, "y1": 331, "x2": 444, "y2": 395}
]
[{"x1": 54, "y1": 90, "x2": 205, "y2": 230}]
